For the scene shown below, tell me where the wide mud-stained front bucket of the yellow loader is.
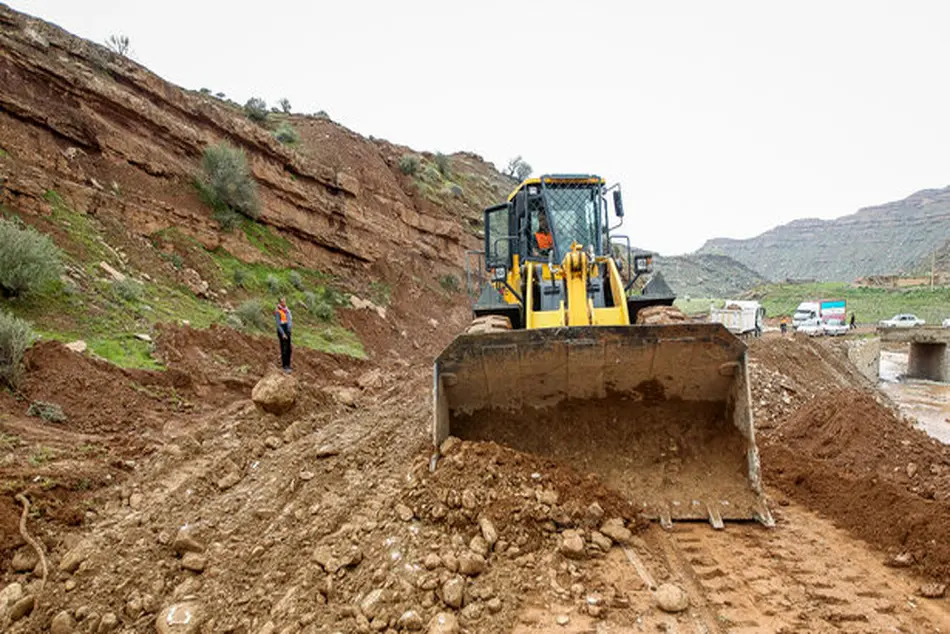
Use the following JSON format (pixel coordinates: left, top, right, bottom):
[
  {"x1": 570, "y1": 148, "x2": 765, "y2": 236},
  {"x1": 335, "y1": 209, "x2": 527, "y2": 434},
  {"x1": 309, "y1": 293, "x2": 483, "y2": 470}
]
[{"x1": 433, "y1": 324, "x2": 773, "y2": 528}]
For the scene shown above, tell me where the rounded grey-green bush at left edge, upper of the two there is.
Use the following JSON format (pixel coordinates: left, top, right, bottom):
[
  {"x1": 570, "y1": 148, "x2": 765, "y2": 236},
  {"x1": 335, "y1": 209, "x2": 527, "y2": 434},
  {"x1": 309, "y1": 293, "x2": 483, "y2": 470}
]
[{"x1": 0, "y1": 218, "x2": 63, "y2": 297}]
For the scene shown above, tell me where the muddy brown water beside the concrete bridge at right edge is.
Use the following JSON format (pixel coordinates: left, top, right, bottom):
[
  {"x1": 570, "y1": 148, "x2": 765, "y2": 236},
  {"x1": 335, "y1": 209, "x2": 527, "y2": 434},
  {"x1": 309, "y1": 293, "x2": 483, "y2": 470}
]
[{"x1": 878, "y1": 350, "x2": 950, "y2": 445}]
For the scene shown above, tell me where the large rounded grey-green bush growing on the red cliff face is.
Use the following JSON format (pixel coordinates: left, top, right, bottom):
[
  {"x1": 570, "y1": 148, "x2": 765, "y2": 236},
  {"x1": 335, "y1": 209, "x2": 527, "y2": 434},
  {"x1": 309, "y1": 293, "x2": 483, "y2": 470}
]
[{"x1": 197, "y1": 143, "x2": 261, "y2": 223}]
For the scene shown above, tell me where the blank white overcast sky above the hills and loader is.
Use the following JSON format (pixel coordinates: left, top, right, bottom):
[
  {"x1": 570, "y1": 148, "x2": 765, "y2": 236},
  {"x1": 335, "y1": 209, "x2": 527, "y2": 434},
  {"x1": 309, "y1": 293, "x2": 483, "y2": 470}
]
[{"x1": 8, "y1": 0, "x2": 950, "y2": 254}]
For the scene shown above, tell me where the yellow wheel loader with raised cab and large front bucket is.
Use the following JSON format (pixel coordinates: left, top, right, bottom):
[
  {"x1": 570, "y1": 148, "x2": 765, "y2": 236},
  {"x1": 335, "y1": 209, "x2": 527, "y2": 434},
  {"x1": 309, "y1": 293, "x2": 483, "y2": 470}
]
[{"x1": 432, "y1": 174, "x2": 773, "y2": 528}]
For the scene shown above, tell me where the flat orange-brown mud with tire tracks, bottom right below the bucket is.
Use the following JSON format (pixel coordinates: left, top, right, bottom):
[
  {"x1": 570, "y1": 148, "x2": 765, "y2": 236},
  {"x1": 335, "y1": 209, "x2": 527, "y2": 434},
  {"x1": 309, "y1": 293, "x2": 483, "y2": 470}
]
[{"x1": 643, "y1": 509, "x2": 950, "y2": 633}]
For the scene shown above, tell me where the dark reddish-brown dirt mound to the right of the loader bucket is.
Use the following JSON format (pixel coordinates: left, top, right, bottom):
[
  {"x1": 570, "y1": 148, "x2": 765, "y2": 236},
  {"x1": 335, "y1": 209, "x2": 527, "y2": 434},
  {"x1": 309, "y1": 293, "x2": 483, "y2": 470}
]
[{"x1": 760, "y1": 390, "x2": 950, "y2": 579}]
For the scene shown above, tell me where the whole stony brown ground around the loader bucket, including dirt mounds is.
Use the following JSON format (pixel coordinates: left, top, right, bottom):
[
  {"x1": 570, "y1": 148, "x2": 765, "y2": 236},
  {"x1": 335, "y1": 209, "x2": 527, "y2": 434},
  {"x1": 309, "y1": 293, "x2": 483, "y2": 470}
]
[{"x1": 0, "y1": 326, "x2": 950, "y2": 633}]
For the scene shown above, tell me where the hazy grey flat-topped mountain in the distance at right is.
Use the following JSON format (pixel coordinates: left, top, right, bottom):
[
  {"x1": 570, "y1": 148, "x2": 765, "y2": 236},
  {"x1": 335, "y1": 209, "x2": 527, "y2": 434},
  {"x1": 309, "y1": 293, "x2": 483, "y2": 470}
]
[{"x1": 696, "y1": 187, "x2": 950, "y2": 282}]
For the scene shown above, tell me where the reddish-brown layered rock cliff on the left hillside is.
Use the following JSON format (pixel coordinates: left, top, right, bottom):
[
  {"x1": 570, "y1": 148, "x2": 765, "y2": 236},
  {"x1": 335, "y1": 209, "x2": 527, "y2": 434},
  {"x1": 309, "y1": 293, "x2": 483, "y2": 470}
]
[{"x1": 0, "y1": 5, "x2": 510, "y2": 280}]
